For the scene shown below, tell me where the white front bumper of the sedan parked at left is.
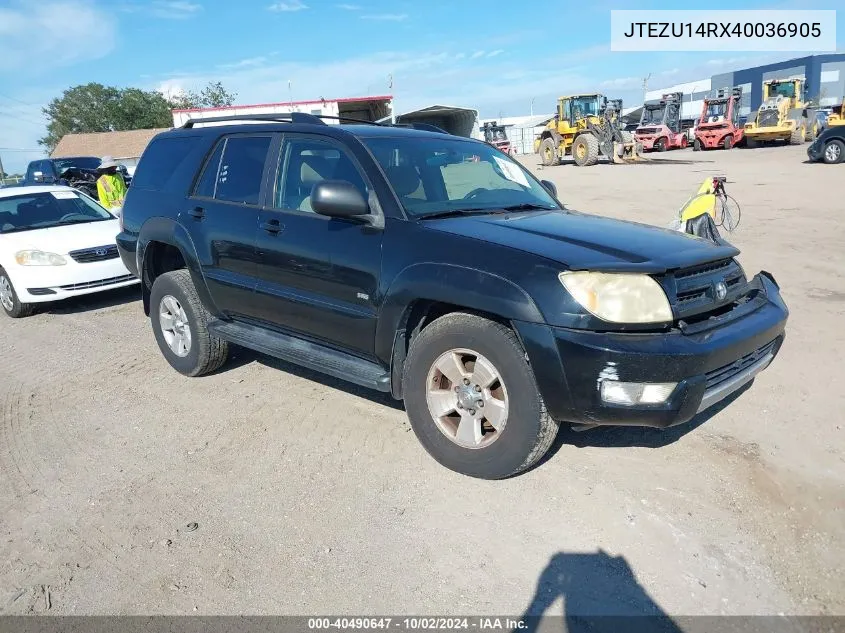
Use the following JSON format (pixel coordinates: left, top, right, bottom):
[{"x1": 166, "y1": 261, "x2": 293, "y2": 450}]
[{"x1": 6, "y1": 256, "x2": 140, "y2": 303}]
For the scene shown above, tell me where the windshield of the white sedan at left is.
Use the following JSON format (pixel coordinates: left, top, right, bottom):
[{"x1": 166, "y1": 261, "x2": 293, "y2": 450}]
[{"x1": 0, "y1": 190, "x2": 114, "y2": 233}]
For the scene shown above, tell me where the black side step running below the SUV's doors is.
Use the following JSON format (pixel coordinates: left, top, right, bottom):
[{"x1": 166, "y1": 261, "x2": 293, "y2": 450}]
[{"x1": 208, "y1": 321, "x2": 390, "y2": 392}]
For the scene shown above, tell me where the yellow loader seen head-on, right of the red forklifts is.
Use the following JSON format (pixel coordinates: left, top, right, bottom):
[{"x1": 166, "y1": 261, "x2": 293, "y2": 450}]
[{"x1": 745, "y1": 79, "x2": 818, "y2": 147}]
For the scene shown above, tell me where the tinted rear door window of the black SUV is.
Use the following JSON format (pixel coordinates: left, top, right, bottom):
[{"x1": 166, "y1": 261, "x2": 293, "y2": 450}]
[{"x1": 214, "y1": 136, "x2": 271, "y2": 204}]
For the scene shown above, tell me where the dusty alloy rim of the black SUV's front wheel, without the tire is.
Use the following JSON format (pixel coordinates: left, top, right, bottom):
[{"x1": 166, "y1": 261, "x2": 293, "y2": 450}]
[{"x1": 426, "y1": 349, "x2": 508, "y2": 449}]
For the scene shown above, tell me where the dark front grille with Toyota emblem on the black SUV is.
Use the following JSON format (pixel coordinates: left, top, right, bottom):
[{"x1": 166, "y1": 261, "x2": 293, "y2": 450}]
[{"x1": 662, "y1": 259, "x2": 746, "y2": 319}]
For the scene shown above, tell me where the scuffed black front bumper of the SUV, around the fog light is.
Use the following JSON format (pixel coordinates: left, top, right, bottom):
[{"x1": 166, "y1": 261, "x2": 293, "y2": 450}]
[{"x1": 516, "y1": 274, "x2": 789, "y2": 428}]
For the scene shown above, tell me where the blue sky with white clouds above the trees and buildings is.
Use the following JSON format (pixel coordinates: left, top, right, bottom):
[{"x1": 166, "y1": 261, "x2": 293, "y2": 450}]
[{"x1": 0, "y1": 0, "x2": 845, "y2": 172}]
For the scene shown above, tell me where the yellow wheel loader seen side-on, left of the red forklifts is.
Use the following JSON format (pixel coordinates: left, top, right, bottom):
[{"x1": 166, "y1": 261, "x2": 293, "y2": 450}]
[{"x1": 534, "y1": 94, "x2": 646, "y2": 167}]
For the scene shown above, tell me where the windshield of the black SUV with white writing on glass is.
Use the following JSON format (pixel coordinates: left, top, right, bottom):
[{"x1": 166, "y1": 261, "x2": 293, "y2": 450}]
[{"x1": 361, "y1": 137, "x2": 560, "y2": 217}]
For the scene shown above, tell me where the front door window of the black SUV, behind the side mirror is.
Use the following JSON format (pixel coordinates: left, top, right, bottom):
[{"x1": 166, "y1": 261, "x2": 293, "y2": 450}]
[{"x1": 274, "y1": 138, "x2": 367, "y2": 211}]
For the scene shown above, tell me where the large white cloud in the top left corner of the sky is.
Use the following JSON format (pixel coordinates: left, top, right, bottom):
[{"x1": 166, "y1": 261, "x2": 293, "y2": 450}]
[{"x1": 0, "y1": 0, "x2": 116, "y2": 69}]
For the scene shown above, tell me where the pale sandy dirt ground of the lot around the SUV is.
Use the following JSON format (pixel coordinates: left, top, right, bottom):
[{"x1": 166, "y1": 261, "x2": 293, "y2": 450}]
[{"x1": 0, "y1": 141, "x2": 845, "y2": 615}]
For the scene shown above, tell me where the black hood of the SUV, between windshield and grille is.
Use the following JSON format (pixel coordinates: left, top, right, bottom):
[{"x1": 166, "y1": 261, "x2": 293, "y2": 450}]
[{"x1": 423, "y1": 210, "x2": 739, "y2": 274}]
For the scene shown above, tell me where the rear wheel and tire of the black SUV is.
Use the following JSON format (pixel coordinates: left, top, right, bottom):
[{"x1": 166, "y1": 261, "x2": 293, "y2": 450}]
[{"x1": 150, "y1": 270, "x2": 229, "y2": 376}]
